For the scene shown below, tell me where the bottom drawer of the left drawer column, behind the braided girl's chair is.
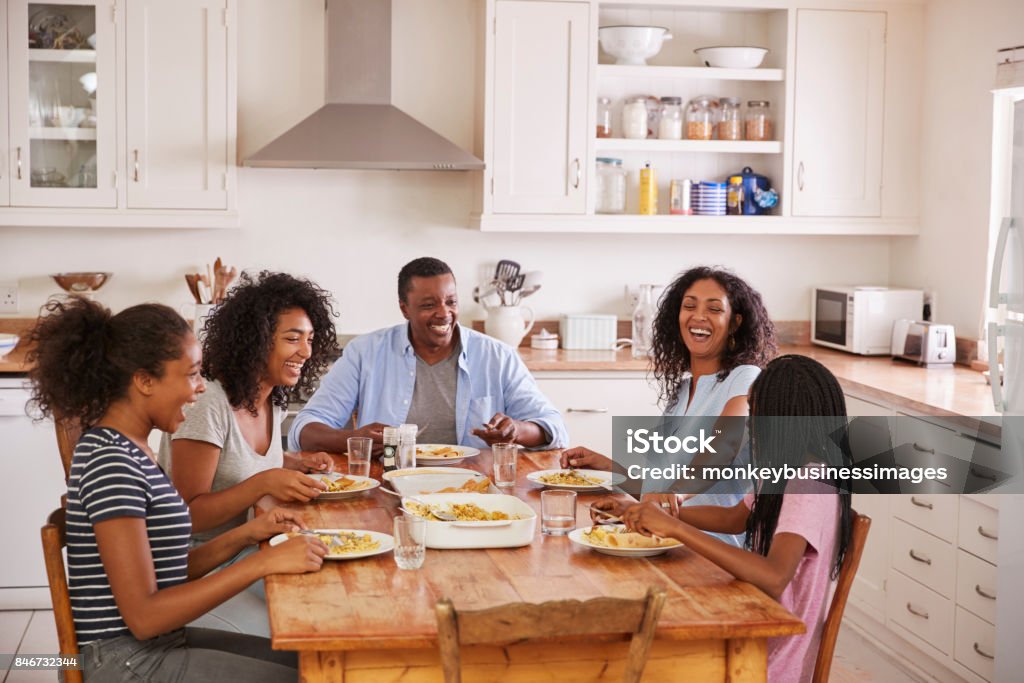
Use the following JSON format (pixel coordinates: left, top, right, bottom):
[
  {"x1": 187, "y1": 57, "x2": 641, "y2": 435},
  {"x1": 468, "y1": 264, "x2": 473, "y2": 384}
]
[{"x1": 886, "y1": 569, "x2": 953, "y2": 654}]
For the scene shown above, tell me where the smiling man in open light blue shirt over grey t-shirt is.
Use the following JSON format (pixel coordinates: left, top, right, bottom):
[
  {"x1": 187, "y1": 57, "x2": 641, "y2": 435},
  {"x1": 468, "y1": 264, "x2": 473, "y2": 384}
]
[{"x1": 288, "y1": 257, "x2": 568, "y2": 453}]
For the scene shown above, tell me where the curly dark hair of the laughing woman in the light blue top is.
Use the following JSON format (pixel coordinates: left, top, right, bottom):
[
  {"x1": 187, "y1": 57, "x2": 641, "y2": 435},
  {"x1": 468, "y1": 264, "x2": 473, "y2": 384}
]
[{"x1": 651, "y1": 266, "x2": 778, "y2": 409}]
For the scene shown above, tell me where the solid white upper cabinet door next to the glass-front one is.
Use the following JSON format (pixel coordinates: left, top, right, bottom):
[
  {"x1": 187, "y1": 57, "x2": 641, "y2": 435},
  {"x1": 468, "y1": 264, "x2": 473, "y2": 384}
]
[{"x1": 125, "y1": 0, "x2": 231, "y2": 209}]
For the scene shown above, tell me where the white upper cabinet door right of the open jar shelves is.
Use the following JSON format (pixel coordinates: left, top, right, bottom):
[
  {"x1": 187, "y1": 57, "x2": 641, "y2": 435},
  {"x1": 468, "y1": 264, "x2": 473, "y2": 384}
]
[{"x1": 793, "y1": 9, "x2": 886, "y2": 216}]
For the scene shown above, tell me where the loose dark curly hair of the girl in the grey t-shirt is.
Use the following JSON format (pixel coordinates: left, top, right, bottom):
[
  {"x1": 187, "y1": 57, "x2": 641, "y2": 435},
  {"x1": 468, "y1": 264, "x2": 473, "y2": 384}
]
[{"x1": 203, "y1": 270, "x2": 338, "y2": 415}]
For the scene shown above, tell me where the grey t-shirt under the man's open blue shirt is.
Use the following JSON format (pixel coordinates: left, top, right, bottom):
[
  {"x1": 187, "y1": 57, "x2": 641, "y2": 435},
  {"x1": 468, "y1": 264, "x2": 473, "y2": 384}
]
[{"x1": 406, "y1": 344, "x2": 460, "y2": 444}]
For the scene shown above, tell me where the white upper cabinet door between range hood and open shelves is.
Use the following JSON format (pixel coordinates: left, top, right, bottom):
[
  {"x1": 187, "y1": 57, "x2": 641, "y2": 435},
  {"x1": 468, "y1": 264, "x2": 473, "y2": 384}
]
[{"x1": 490, "y1": 0, "x2": 592, "y2": 214}]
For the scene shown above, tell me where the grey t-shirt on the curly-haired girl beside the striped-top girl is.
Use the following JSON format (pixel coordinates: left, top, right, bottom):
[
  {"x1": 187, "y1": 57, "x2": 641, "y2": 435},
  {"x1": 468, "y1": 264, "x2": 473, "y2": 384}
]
[{"x1": 157, "y1": 380, "x2": 285, "y2": 542}]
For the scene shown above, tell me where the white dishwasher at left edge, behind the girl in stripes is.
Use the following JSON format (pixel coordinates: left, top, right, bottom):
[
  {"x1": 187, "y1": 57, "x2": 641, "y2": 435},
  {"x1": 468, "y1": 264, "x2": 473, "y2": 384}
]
[{"x1": 0, "y1": 374, "x2": 67, "y2": 609}]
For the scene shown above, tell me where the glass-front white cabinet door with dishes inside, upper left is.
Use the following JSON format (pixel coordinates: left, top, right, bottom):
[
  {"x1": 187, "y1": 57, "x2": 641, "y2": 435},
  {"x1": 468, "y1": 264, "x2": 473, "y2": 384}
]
[{"x1": 7, "y1": 0, "x2": 117, "y2": 208}]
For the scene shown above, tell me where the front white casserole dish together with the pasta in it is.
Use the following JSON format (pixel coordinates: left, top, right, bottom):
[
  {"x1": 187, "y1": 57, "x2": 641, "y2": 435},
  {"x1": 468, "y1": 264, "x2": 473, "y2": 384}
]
[{"x1": 401, "y1": 494, "x2": 537, "y2": 549}]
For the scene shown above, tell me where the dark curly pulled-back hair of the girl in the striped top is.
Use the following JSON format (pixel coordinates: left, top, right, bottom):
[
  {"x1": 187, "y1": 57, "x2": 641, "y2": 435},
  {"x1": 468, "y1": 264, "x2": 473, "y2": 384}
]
[{"x1": 29, "y1": 297, "x2": 191, "y2": 429}]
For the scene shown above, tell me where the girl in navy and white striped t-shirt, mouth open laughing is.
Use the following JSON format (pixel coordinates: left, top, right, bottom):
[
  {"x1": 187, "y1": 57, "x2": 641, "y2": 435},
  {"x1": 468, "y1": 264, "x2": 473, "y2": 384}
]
[{"x1": 30, "y1": 299, "x2": 327, "y2": 683}]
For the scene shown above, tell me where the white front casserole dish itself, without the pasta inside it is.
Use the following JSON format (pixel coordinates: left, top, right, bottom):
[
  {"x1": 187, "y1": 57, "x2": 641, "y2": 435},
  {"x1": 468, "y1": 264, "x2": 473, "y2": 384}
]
[{"x1": 401, "y1": 494, "x2": 537, "y2": 550}]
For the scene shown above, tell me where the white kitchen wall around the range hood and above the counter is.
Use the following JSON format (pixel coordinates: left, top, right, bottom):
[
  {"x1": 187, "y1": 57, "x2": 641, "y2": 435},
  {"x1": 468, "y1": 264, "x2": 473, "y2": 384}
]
[{"x1": 0, "y1": 0, "x2": 892, "y2": 333}]
